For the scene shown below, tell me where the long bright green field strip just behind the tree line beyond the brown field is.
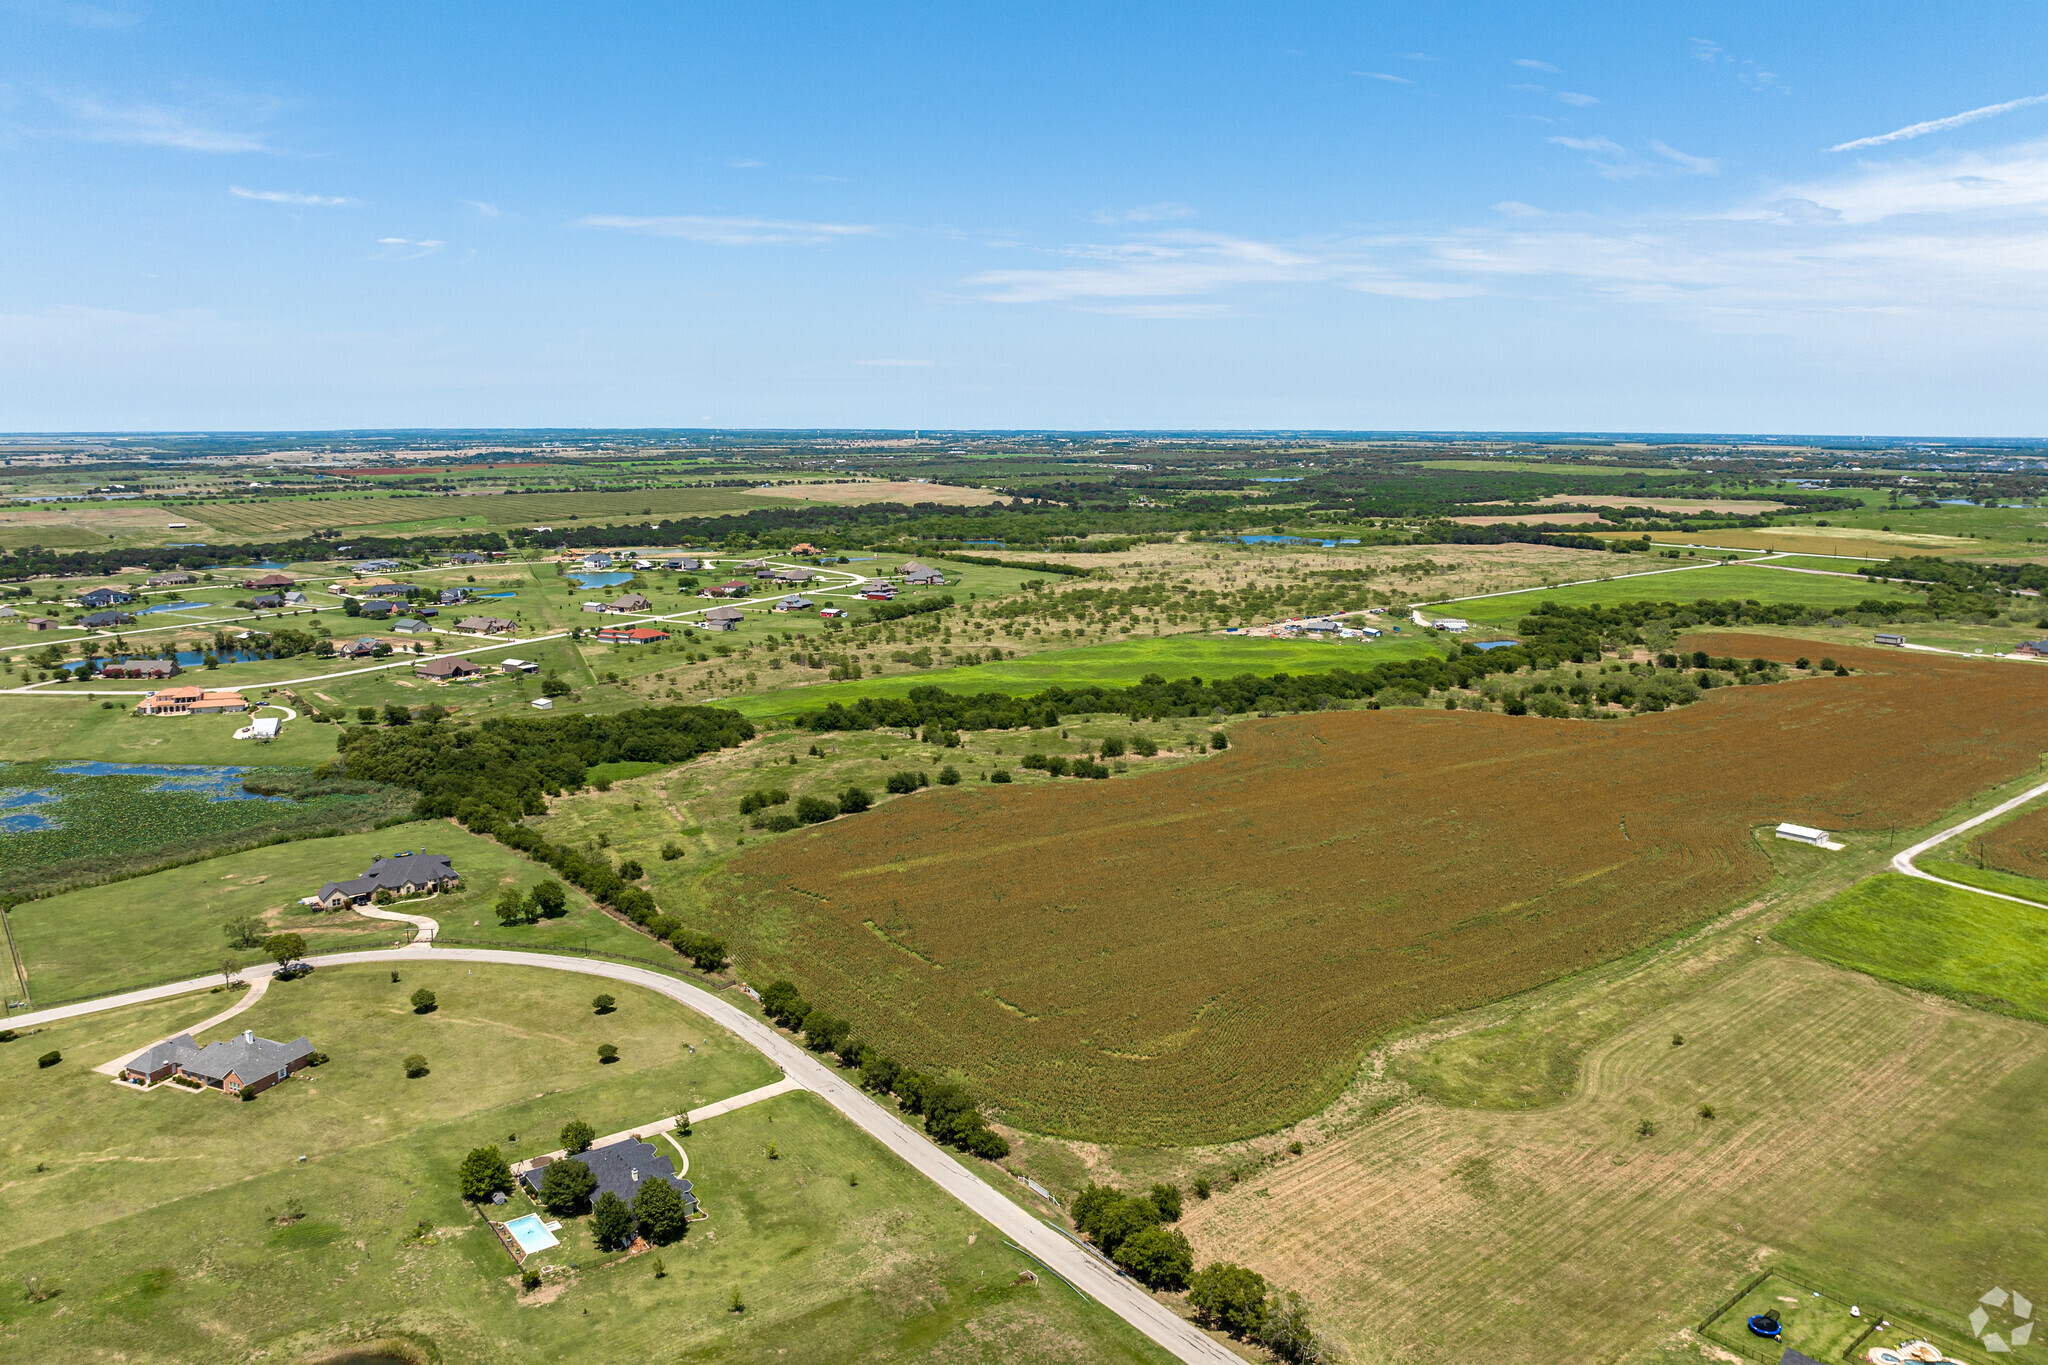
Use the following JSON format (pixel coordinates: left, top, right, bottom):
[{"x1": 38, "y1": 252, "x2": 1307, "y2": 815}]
[{"x1": 729, "y1": 634, "x2": 1434, "y2": 718}]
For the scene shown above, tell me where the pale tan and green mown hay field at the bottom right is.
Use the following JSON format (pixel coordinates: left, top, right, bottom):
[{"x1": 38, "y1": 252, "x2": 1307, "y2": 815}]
[{"x1": 1182, "y1": 957, "x2": 2048, "y2": 1365}]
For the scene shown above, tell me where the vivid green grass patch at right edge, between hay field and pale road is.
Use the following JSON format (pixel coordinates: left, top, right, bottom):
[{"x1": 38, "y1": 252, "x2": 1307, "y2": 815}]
[{"x1": 1774, "y1": 866, "x2": 2048, "y2": 1023}]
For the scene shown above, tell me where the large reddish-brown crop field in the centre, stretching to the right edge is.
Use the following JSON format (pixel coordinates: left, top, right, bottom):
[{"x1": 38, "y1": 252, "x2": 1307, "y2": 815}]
[{"x1": 698, "y1": 634, "x2": 2048, "y2": 1142}]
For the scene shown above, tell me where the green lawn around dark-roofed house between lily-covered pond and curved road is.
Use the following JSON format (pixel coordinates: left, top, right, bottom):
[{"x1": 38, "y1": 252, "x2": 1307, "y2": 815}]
[{"x1": 12, "y1": 821, "x2": 647, "y2": 1007}]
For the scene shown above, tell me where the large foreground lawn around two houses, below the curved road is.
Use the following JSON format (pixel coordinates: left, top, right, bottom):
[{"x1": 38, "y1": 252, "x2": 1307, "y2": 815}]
[{"x1": 0, "y1": 962, "x2": 1167, "y2": 1365}]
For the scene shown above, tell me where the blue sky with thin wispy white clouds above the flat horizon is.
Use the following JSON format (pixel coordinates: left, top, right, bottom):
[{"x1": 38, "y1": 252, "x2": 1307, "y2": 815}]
[{"x1": 0, "y1": 0, "x2": 2048, "y2": 436}]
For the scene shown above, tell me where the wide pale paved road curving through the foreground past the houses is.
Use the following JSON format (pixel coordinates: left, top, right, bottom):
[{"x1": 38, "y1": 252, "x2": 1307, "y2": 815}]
[{"x1": 8, "y1": 945, "x2": 1236, "y2": 1365}]
